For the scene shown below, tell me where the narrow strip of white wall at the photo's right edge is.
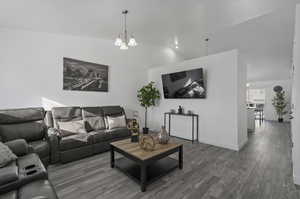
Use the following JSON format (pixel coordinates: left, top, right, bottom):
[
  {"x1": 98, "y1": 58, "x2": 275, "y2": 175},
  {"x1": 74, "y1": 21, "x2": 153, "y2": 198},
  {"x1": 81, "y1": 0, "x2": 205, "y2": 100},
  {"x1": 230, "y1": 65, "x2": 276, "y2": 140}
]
[{"x1": 292, "y1": 4, "x2": 300, "y2": 185}]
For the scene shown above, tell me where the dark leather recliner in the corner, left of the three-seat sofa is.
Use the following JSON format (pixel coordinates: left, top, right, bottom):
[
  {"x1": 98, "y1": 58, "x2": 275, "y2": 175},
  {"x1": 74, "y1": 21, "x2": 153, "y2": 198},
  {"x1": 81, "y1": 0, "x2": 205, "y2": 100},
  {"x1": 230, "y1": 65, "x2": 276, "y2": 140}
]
[{"x1": 0, "y1": 108, "x2": 58, "y2": 166}]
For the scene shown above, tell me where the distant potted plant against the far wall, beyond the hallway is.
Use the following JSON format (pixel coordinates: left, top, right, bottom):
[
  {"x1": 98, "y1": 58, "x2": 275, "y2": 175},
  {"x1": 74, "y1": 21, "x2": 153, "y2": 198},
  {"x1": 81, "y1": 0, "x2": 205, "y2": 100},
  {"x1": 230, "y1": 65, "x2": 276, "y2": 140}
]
[{"x1": 272, "y1": 86, "x2": 288, "y2": 122}]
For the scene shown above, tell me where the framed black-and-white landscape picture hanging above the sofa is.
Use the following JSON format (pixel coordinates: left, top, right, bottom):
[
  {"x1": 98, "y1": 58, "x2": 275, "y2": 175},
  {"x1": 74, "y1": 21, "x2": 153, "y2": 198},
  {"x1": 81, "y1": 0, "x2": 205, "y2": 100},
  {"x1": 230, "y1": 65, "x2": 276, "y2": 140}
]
[{"x1": 63, "y1": 57, "x2": 108, "y2": 92}]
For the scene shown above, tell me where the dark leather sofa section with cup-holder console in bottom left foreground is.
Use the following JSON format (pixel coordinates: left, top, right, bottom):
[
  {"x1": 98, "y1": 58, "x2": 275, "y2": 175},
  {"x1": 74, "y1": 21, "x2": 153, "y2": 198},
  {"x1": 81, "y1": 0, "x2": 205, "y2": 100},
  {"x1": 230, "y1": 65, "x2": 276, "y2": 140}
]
[{"x1": 0, "y1": 139, "x2": 58, "y2": 199}]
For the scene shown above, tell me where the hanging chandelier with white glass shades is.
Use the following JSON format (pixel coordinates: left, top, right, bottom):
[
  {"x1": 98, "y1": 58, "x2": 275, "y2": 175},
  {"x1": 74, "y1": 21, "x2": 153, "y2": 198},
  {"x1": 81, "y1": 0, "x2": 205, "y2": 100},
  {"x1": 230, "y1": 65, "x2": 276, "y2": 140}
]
[{"x1": 115, "y1": 10, "x2": 137, "y2": 50}]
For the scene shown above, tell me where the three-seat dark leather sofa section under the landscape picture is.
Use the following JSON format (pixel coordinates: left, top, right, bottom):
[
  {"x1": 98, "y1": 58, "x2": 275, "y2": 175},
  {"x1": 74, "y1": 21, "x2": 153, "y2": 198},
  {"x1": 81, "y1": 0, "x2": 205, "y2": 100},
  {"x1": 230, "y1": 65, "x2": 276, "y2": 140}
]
[{"x1": 51, "y1": 106, "x2": 131, "y2": 163}]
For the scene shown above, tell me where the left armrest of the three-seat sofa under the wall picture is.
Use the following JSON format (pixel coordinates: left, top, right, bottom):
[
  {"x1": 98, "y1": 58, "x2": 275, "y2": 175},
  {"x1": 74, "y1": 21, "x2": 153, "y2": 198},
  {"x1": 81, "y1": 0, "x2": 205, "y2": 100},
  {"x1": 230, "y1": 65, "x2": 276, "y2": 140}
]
[{"x1": 47, "y1": 128, "x2": 61, "y2": 163}]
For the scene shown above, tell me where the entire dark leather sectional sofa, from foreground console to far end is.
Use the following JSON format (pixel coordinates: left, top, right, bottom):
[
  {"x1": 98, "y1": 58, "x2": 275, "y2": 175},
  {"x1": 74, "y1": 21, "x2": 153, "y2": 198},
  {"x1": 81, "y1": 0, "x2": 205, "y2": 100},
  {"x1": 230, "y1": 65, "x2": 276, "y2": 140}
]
[{"x1": 0, "y1": 106, "x2": 131, "y2": 199}]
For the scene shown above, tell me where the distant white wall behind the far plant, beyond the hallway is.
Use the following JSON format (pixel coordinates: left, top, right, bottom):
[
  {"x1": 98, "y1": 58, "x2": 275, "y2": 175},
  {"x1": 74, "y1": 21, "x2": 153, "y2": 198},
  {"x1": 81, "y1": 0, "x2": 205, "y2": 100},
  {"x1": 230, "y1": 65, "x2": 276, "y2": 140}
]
[{"x1": 249, "y1": 80, "x2": 292, "y2": 121}]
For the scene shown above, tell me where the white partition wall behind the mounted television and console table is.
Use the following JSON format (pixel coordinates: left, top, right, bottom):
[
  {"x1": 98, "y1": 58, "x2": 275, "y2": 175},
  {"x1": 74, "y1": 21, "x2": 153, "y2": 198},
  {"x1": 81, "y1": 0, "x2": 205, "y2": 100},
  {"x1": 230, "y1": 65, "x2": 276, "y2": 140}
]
[{"x1": 148, "y1": 50, "x2": 247, "y2": 150}]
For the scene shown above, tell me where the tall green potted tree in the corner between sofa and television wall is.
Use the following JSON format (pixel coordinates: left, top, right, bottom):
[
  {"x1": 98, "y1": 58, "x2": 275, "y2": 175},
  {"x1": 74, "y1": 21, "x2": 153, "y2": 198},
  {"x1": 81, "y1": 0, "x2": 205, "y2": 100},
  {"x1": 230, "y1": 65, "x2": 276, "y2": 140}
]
[{"x1": 137, "y1": 82, "x2": 160, "y2": 134}]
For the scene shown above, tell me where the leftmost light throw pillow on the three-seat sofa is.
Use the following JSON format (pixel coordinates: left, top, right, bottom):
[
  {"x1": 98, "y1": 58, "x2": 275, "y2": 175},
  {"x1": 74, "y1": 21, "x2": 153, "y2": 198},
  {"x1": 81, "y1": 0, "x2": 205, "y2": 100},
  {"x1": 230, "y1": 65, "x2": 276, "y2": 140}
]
[{"x1": 57, "y1": 120, "x2": 86, "y2": 137}]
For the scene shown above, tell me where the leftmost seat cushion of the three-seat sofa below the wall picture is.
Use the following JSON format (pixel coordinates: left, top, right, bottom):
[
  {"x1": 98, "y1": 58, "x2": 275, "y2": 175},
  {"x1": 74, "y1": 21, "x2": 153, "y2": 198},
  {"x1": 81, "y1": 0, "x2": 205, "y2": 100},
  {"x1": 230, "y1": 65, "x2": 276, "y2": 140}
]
[{"x1": 59, "y1": 134, "x2": 93, "y2": 151}]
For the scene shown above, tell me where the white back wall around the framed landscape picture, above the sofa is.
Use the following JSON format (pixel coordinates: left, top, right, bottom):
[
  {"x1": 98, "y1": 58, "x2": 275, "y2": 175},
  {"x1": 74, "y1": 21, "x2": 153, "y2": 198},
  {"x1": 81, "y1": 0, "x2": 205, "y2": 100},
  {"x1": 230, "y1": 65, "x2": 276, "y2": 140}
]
[{"x1": 0, "y1": 29, "x2": 183, "y2": 119}]
